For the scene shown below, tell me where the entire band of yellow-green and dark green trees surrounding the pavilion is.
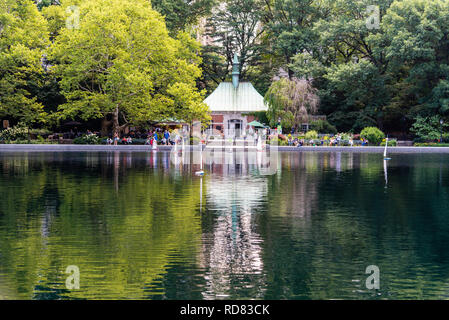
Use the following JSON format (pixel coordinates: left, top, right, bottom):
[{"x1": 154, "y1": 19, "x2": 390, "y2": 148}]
[{"x1": 0, "y1": 0, "x2": 449, "y2": 139}]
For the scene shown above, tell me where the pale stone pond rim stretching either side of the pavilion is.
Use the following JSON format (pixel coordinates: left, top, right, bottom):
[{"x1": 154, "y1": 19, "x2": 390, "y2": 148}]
[{"x1": 0, "y1": 144, "x2": 449, "y2": 154}]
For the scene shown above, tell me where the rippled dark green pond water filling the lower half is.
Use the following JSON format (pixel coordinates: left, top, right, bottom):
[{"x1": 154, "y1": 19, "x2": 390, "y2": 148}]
[{"x1": 0, "y1": 151, "x2": 449, "y2": 299}]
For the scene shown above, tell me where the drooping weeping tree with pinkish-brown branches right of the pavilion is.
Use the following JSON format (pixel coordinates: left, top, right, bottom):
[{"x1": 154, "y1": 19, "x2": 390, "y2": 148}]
[{"x1": 265, "y1": 76, "x2": 319, "y2": 128}]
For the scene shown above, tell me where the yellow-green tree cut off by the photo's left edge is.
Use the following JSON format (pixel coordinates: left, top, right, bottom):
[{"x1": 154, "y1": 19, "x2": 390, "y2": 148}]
[{"x1": 0, "y1": 0, "x2": 49, "y2": 125}]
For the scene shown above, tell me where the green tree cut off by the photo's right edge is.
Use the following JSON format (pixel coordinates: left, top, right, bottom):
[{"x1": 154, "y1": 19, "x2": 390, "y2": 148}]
[{"x1": 383, "y1": 0, "x2": 449, "y2": 115}]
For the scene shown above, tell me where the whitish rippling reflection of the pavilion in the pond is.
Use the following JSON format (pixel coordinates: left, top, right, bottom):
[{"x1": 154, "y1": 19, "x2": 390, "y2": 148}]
[{"x1": 199, "y1": 152, "x2": 268, "y2": 299}]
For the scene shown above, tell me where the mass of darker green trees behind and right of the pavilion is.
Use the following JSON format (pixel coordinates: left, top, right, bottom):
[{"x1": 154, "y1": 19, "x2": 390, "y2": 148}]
[{"x1": 198, "y1": 0, "x2": 449, "y2": 133}]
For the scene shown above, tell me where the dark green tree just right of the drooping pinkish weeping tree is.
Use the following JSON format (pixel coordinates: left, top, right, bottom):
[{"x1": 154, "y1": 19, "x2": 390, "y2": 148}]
[{"x1": 292, "y1": 0, "x2": 391, "y2": 131}]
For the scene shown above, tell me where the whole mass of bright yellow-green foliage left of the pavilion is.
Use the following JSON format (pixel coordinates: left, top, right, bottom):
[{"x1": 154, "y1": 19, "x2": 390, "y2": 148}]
[{"x1": 0, "y1": 0, "x2": 208, "y2": 132}]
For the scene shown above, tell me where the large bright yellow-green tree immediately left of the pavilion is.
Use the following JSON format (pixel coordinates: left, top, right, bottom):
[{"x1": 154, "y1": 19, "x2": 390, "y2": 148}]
[{"x1": 51, "y1": 0, "x2": 208, "y2": 133}]
